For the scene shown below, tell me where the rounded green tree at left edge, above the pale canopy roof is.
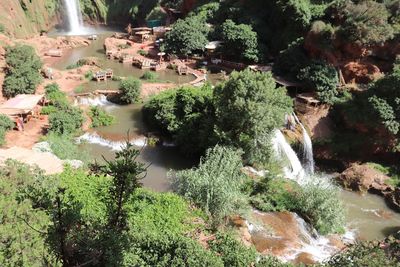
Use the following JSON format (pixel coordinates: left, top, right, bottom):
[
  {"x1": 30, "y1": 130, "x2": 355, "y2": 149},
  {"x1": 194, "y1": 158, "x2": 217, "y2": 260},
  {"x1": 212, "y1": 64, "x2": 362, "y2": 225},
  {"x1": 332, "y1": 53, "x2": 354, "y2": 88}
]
[{"x1": 3, "y1": 45, "x2": 42, "y2": 97}]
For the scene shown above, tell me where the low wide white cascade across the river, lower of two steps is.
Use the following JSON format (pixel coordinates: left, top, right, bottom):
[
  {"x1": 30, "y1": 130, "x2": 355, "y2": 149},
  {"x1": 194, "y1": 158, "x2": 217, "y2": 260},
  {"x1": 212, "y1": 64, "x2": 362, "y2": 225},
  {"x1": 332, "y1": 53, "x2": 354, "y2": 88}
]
[{"x1": 77, "y1": 133, "x2": 147, "y2": 151}]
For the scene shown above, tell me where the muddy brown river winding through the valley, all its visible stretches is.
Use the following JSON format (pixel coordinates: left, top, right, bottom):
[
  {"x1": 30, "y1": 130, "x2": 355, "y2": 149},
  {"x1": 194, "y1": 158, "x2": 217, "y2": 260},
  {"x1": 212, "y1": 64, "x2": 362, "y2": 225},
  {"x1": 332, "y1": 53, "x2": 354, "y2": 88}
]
[{"x1": 48, "y1": 26, "x2": 400, "y2": 260}]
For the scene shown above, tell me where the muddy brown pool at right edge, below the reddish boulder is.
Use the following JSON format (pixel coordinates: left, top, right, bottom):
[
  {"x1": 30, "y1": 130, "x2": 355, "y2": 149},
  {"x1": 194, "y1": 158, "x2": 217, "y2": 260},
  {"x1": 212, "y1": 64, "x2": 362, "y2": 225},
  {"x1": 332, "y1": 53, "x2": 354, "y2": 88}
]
[{"x1": 341, "y1": 190, "x2": 400, "y2": 240}]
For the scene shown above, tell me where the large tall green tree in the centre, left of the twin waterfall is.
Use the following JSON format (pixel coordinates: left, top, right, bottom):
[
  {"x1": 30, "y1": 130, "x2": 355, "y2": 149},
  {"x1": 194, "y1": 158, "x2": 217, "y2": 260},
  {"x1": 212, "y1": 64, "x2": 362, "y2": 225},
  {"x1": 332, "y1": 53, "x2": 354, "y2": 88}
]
[{"x1": 214, "y1": 69, "x2": 292, "y2": 164}]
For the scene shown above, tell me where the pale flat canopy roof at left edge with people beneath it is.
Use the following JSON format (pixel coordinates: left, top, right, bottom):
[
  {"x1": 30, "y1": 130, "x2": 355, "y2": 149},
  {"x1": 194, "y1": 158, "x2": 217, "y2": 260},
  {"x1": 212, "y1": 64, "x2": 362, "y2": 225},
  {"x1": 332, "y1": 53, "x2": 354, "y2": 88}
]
[{"x1": 0, "y1": 95, "x2": 43, "y2": 116}]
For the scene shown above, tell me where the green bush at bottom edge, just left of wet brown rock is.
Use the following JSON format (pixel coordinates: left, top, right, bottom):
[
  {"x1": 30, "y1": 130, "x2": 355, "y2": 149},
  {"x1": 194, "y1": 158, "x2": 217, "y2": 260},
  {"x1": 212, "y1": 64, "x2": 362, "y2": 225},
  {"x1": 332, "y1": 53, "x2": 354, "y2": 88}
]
[{"x1": 209, "y1": 233, "x2": 256, "y2": 267}]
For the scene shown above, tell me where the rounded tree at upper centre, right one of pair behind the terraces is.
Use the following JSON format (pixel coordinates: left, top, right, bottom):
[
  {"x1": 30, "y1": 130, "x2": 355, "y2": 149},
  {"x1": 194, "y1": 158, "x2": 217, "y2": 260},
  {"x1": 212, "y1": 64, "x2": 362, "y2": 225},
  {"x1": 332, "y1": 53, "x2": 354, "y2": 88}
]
[{"x1": 221, "y1": 19, "x2": 259, "y2": 62}]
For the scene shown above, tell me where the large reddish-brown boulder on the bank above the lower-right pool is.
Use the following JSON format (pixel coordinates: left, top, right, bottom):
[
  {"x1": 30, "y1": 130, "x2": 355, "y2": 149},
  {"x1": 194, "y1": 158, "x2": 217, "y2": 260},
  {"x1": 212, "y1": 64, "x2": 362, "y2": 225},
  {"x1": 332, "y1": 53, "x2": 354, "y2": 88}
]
[{"x1": 337, "y1": 163, "x2": 393, "y2": 194}]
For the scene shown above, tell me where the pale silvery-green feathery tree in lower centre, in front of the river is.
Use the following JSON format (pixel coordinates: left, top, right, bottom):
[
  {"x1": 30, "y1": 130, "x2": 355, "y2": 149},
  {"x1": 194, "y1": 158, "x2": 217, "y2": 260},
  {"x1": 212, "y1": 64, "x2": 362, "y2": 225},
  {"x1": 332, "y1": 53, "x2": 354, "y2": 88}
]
[{"x1": 172, "y1": 145, "x2": 246, "y2": 226}]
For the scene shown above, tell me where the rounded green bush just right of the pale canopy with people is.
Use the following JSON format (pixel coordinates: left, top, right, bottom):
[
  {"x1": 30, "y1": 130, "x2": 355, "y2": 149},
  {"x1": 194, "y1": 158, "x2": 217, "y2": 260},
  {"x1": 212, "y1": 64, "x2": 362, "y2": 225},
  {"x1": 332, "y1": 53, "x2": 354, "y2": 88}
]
[{"x1": 49, "y1": 107, "x2": 83, "y2": 135}]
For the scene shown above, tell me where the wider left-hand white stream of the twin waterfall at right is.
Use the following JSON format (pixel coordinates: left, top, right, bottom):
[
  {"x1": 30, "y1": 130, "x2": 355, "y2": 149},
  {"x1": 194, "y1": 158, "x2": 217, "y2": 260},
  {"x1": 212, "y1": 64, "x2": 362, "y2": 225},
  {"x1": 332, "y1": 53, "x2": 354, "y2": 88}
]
[{"x1": 272, "y1": 130, "x2": 305, "y2": 184}]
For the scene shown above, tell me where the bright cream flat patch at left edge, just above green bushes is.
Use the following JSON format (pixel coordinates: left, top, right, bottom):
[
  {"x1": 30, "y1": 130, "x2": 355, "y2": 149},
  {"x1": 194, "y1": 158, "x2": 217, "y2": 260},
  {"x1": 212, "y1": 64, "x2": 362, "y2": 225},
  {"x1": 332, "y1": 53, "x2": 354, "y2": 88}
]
[{"x1": 0, "y1": 147, "x2": 64, "y2": 175}]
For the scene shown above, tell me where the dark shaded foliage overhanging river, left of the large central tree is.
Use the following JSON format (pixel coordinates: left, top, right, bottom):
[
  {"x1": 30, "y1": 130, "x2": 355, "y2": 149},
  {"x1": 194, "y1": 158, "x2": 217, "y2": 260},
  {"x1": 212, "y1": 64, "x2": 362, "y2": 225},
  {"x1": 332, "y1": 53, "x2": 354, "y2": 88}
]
[{"x1": 143, "y1": 85, "x2": 216, "y2": 155}]
